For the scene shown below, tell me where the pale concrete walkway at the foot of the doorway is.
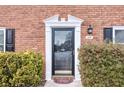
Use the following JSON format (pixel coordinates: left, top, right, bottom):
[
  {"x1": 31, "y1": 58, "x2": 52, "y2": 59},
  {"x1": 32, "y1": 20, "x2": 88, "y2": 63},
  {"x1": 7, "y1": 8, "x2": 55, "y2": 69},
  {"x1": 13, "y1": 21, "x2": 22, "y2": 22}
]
[{"x1": 45, "y1": 80, "x2": 82, "y2": 87}]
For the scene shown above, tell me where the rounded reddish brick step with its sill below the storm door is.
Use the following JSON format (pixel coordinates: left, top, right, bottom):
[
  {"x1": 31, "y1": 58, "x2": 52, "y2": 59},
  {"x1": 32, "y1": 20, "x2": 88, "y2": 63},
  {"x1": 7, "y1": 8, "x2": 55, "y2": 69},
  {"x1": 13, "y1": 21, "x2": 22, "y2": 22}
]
[{"x1": 52, "y1": 75, "x2": 74, "y2": 84}]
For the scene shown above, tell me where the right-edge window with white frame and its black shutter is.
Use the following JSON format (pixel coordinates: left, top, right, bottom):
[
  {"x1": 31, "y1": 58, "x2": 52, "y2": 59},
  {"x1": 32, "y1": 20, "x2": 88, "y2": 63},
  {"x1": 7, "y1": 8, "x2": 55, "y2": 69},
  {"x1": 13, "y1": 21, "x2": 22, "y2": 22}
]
[{"x1": 104, "y1": 26, "x2": 124, "y2": 44}]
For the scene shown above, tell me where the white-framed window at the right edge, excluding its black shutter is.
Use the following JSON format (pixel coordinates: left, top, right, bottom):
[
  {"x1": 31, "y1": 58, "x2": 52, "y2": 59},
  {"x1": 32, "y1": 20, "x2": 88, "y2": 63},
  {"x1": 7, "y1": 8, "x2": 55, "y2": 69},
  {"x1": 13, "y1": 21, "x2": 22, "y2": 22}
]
[{"x1": 113, "y1": 26, "x2": 124, "y2": 44}]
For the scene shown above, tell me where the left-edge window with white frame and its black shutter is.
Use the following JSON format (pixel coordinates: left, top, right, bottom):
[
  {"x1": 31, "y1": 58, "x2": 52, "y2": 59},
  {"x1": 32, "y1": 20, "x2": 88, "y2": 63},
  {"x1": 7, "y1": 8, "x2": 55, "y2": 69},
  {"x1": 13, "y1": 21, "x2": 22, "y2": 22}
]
[{"x1": 0, "y1": 28, "x2": 15, "y2": 52}]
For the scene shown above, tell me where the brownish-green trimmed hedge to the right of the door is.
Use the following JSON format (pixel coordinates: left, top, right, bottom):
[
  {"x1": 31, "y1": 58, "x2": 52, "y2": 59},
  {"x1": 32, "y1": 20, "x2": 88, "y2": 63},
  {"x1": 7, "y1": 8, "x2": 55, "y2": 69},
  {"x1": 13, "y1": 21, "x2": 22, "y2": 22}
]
[{"x1": 79, "y1": 44, "x2": 124, "y2": 87}]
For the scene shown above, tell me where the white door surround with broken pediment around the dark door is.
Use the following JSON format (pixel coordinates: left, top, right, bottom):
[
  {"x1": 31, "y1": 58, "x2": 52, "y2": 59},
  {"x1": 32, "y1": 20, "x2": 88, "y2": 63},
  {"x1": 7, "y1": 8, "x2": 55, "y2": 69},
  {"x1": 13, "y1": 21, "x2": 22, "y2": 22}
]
[{"x1": 44, "y1": 15, "x2": 84, "y2": 80}]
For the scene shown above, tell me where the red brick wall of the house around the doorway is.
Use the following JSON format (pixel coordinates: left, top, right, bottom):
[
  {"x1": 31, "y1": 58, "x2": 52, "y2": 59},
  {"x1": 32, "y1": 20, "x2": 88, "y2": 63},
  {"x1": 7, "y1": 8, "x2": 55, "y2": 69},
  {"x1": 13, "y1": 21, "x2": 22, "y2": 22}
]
[{"x1": 0, "y1": 5, "x2": 124, "y2": 55}]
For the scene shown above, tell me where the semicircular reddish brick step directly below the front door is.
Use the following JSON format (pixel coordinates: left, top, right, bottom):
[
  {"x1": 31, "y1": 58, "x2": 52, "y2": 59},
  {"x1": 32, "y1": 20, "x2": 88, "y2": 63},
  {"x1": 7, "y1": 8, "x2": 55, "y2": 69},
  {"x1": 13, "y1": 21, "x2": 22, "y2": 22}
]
[{"x1": 53, "y1": 76, "x2": 74, "y2": 84}]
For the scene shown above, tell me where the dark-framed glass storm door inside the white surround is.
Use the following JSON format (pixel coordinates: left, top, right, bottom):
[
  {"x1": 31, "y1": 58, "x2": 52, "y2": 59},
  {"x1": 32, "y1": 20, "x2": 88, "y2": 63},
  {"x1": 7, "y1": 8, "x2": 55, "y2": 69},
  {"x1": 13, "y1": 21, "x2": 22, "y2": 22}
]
[{"x1": 52, "y1": 28, "x2": 74, "y2": 75}]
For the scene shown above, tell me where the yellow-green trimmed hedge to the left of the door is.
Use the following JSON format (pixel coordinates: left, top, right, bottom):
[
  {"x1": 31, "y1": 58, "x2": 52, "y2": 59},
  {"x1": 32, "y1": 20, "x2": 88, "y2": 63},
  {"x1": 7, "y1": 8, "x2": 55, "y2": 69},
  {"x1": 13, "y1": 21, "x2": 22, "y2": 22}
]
[{"x1": 0, "y1": 51, "x2": 43, "y2": 87}]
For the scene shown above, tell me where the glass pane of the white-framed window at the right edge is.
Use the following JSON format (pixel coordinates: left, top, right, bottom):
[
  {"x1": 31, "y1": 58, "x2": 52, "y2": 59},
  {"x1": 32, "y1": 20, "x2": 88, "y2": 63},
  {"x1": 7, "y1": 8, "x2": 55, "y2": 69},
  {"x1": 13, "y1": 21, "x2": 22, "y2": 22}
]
[{"x1": 115, "y1": 30, "x2": 124, "y2": 43}]
